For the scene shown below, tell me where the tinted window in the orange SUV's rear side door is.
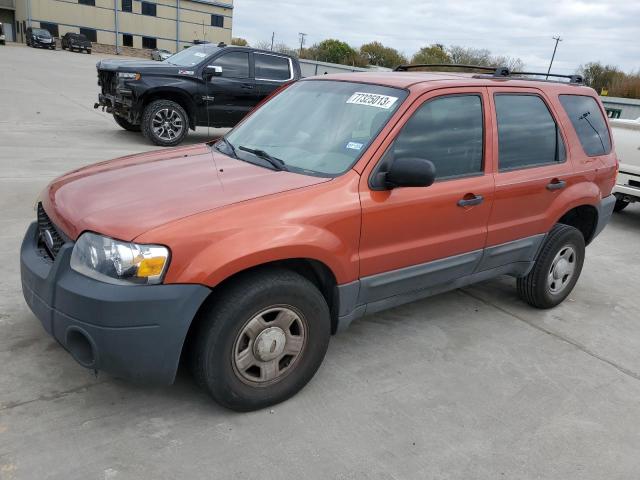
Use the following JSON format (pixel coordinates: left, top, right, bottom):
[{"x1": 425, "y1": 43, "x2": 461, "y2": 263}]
[{"x1": 495, "y1": 94, "x2": 565, "y2": 170}]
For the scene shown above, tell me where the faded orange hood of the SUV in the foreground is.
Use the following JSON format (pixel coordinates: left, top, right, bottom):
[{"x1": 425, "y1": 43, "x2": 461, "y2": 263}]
[{"x1": 41, "y1": 144, "x2": 330, "y2": 241}]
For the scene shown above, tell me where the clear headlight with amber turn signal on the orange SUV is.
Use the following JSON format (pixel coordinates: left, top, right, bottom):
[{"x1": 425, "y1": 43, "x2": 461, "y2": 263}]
[{"x1": 71, "y1": 232, "x2": 169, "y2": 285}]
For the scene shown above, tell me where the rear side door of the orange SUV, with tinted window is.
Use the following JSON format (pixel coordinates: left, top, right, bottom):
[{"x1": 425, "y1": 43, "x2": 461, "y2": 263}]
[{"x1": 487, "y1": 87, "x2": 574, "y2": 248}]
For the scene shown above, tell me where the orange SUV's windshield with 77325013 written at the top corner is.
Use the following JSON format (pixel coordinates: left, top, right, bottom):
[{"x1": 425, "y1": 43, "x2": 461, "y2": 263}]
[{"x1": 226, "y1": 80, "x2": 407, "y2": 177}]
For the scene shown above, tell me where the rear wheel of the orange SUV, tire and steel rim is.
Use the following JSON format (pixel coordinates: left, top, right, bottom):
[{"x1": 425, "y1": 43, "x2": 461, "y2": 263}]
[{"x1": 517, "y1": 224, "x2": 585, "y2": 308}]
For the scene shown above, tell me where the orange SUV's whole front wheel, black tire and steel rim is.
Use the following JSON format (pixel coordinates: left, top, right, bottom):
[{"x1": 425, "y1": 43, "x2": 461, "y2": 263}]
[{"x1": 190, "y1": 269, "x2": 331, "y2": 411}]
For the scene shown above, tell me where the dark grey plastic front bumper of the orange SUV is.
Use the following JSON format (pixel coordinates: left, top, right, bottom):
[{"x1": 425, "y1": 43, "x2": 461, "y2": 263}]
[{"x1": 20, "y1": 223, "x2": 210, "y2": 385}]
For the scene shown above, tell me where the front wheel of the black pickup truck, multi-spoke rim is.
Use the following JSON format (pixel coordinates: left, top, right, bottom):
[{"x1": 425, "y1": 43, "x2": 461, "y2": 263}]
[{"x1": 142, "y1": 100, "x2": 189, "y2": 147}]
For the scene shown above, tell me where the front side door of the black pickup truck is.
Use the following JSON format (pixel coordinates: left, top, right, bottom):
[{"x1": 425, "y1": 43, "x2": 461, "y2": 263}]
[{"x1": 204, "y1": 51, "x2": 260, "y2": 127}]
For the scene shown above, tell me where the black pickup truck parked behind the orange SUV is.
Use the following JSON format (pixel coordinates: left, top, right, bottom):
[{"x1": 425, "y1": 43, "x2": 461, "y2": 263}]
[{"x1": 94, "y1": 43, "x2": 300, "y2": 146}]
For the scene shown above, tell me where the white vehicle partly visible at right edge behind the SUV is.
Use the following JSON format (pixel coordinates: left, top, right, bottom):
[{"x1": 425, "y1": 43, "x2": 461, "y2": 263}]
[{"x1": 609, "y1": 118, "x2": 640, "y2": 212}]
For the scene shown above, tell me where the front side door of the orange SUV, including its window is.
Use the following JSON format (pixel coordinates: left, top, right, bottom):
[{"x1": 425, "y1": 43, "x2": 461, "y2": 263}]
[{"x1": 360, "y1": 88, "x2": 494, "y2": 303}]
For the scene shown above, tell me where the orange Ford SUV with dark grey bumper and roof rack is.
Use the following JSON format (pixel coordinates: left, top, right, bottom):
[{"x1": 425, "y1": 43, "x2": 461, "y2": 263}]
[{"x1": 21, "y1": 66, "x2": 617, "y2": 410}]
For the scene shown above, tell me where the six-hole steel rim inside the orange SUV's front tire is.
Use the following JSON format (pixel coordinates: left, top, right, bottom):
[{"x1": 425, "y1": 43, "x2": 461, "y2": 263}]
[{"x1": 231, "y1": 305, "x2": 308, "y2": 386}]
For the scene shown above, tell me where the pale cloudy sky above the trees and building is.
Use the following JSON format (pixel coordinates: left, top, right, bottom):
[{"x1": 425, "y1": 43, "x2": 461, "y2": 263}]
[{"x1": 233, "y1": 0, "x2": 640, "y2": 74}]
